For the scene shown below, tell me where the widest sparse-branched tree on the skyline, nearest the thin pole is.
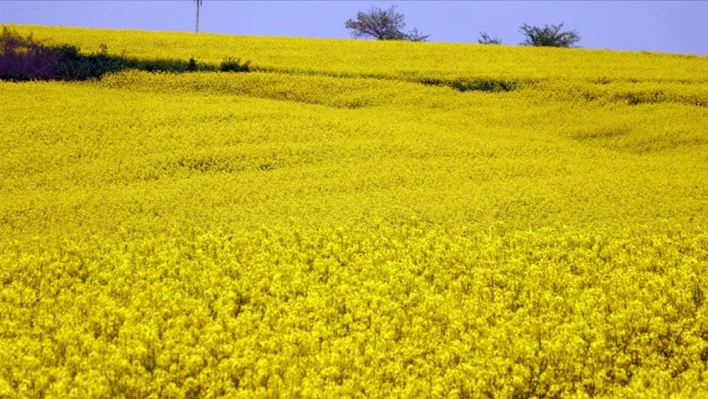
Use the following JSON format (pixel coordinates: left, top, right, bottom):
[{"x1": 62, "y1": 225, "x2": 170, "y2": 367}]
[{"x1": 344, "y1": 6, "x2": 430, "y2": 42}]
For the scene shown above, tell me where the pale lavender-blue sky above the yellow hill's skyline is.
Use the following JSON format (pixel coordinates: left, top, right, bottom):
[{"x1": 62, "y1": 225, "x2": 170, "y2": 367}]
[{"x1": 0, "y1": 0, "x2": 708, "y2": 55}]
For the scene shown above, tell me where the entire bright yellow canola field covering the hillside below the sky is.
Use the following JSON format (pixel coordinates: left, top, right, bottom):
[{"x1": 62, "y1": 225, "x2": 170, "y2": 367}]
[{"x1": 0, "y1": 26, "x2": 708, "y2": 398}]
